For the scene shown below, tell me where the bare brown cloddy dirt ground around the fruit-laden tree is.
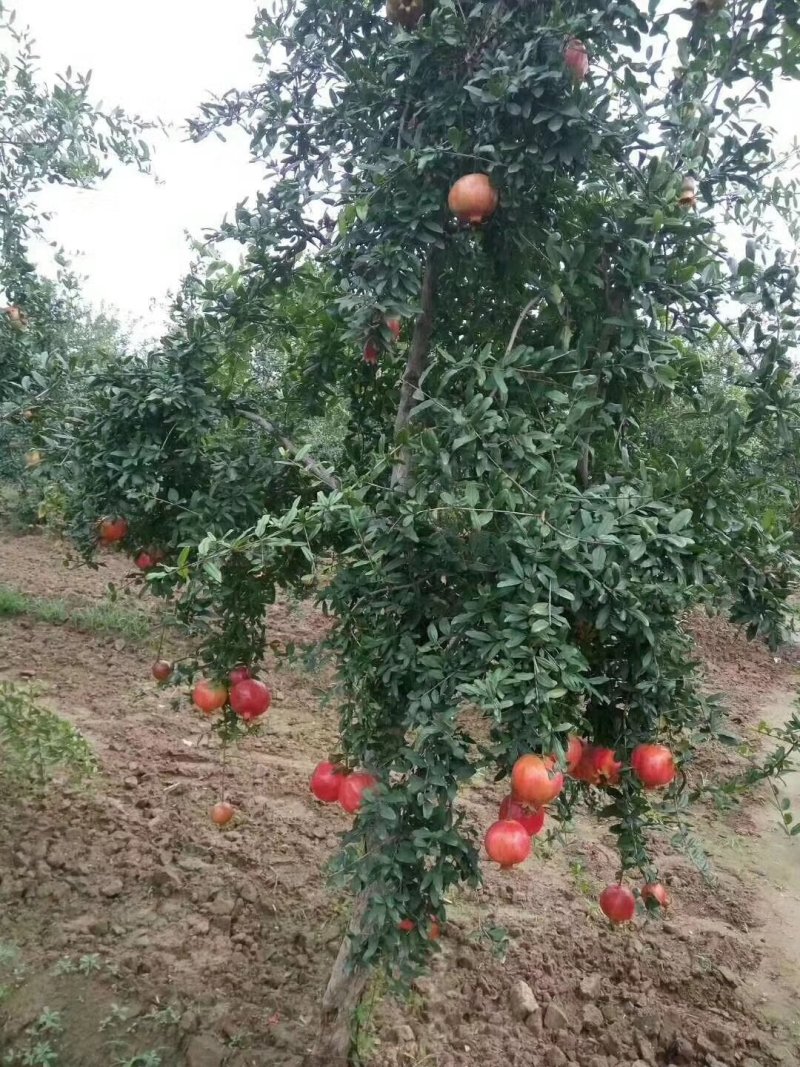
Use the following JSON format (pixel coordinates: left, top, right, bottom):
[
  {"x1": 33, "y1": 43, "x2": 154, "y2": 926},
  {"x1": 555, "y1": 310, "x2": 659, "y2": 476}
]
[{"x1": 0, "y1": 535, "x2": 800, "y2": 1067}]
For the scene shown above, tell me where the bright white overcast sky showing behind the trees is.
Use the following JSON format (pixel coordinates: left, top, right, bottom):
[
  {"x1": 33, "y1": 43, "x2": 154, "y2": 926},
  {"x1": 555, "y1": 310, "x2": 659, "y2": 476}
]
[{"x1": 9, "y1": 0, "x2": 800, "y2": 336}]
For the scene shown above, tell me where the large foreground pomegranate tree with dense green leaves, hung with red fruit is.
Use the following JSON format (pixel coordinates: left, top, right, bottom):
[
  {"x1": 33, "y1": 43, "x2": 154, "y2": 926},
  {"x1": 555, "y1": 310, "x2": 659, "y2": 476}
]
[{"x1": 42, "y1": 0, "x2": 798, "y2": 1065}]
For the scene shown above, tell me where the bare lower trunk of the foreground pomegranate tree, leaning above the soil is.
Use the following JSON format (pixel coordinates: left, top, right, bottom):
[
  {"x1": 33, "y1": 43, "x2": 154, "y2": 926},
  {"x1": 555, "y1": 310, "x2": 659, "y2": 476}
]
[{"x1": 303, "y1": 894, "x2": 369, "y2": 1067}]
